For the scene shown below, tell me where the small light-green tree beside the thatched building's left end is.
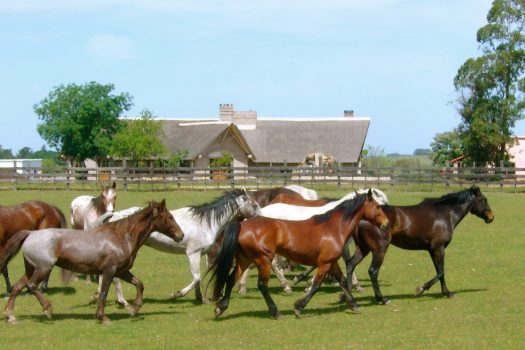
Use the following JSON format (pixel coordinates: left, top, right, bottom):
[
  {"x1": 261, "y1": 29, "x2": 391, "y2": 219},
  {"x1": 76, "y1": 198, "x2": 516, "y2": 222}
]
[{"x1": 111, "y1": 109, "x2": 167, "y2": 162}]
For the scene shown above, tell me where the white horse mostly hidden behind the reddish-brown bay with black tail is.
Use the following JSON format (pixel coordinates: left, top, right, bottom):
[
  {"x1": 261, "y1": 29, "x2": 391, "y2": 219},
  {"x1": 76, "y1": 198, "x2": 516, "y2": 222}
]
[{"x1": 239, "y1": 188, "x2": 388, "y2": 294}]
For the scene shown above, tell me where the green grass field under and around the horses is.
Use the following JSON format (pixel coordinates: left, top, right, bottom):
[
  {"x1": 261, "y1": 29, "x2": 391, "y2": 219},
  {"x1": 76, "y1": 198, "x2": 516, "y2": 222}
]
[{"x1": 0, "y1": 191, "x2": 525, "y2": 350}]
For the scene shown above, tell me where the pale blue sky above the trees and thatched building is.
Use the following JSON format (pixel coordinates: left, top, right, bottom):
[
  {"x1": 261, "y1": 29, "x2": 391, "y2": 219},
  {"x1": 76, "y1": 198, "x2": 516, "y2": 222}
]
[{"x1": 0, "y1": 0, "x2": 525, "y2": 154}]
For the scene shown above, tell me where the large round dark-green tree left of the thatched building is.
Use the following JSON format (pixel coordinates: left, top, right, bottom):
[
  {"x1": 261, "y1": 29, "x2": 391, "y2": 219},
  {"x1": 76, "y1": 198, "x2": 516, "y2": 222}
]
[{"x1": 34, "y1": 82, "x2": 132, "y2": 162}]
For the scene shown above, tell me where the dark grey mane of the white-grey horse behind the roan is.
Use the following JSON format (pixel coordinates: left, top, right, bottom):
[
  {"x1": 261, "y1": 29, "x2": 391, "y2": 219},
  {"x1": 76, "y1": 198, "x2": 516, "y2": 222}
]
[{"x1": 190, "y1": 189, "x2": 244, "y2": 226}]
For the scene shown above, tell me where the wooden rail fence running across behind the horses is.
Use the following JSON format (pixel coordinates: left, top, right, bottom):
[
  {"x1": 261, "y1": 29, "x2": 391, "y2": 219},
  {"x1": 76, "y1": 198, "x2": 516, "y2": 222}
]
[{"x1": 0, "y1": 166, "x2": 525, "y2": 192}]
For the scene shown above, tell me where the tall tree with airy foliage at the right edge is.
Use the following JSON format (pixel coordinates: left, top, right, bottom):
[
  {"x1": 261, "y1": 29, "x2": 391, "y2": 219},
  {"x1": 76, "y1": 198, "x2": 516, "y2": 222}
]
[{"x1": 454, "y1": 0, "x2": 525, "y2": 165}]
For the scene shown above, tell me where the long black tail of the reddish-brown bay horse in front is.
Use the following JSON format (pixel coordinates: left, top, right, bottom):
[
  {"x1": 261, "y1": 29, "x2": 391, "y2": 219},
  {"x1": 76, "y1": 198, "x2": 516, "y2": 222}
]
[{"x1": 206, "y1": 222, "x2": 241, "y2": 301}]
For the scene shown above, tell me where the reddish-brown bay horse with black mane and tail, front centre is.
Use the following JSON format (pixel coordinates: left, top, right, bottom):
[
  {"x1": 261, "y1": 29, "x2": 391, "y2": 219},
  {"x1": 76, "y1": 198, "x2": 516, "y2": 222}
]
[{"x1": 209, "y1": 191, "x2": 388, "y2": 319}]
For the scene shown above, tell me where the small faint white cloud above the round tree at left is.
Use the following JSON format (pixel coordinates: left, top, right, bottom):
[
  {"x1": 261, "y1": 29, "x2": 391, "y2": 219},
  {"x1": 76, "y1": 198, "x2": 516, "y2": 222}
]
[{"x1": 85, "y1": 34, "x2": 136, "y2": 60}]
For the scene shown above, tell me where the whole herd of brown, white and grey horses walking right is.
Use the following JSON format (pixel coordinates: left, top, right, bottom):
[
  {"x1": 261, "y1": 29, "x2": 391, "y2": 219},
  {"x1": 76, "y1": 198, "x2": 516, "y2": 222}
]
[{"x1": 0, "y1": 183, "x2": 494, "y2": 323}]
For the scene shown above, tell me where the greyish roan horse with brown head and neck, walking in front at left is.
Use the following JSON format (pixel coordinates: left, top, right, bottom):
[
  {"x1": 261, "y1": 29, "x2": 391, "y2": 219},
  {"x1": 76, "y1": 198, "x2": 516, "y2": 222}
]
[{"x1": 0, "y1": 200, "x2": 184, "y2": 323}]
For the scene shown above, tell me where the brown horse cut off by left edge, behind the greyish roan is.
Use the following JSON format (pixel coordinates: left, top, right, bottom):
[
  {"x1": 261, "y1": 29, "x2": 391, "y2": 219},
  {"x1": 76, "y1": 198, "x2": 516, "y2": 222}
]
[{"x1": 0, "y1": 201, "x2": 67, "y2": 293}]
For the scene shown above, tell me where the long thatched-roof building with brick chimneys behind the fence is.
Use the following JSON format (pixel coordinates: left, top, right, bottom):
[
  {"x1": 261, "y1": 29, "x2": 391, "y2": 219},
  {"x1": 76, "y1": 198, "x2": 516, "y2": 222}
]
[{"x1": 161, "y1": 104, "x2": 370, "y2": 167}]
